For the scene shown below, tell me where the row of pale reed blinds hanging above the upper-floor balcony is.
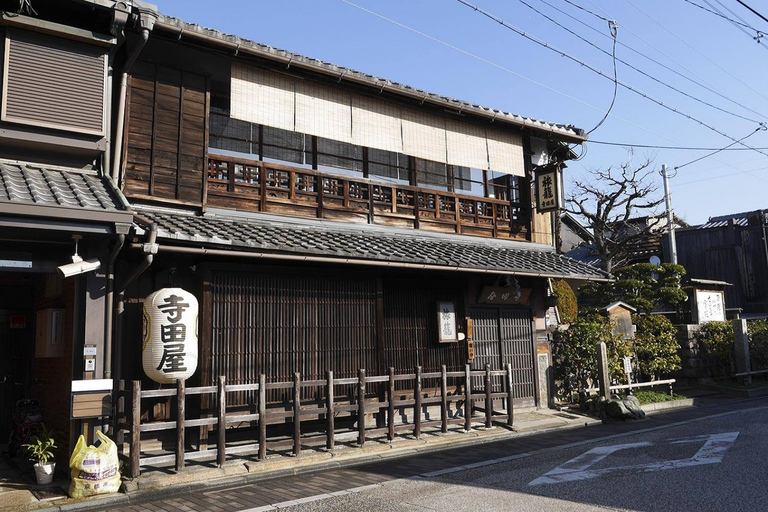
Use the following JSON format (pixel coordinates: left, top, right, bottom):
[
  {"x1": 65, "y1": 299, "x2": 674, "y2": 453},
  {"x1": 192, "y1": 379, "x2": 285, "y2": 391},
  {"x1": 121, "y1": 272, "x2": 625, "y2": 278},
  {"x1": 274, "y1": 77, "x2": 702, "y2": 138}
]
[{"x1": 230, "y1": 62, "x2": 525, "y2": 176}]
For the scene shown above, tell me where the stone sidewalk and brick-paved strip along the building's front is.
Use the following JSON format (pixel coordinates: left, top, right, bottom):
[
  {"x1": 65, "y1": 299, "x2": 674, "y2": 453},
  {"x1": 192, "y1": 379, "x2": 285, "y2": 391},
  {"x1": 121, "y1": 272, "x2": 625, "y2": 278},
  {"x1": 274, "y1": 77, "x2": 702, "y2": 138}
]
[{"x1": 0, "y1": 390, "x2": 750, "y2": 512}]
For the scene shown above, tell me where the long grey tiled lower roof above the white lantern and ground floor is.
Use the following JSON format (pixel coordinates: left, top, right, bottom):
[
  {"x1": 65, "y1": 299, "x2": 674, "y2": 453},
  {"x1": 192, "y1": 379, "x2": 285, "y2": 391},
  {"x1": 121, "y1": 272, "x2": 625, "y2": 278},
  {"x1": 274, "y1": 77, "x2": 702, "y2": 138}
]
[{"x1": 135, "y1": 206, "x2": 608, "y2": 279}]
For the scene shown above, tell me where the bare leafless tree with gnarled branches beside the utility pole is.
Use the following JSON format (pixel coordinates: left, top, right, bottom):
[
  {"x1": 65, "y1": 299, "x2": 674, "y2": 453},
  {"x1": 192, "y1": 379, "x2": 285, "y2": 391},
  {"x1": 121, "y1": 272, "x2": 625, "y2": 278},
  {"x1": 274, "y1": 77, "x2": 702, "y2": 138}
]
[{"x1": 566, "y1": 160, "x2": 664, "y2": 272}]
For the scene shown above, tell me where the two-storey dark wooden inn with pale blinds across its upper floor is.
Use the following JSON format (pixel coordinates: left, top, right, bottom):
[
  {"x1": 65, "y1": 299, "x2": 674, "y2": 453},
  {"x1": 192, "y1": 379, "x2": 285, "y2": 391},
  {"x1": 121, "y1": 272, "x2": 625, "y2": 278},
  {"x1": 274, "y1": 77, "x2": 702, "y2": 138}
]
[{"x1": 111, "y1": 8, "x2": 605, "y2": 406}]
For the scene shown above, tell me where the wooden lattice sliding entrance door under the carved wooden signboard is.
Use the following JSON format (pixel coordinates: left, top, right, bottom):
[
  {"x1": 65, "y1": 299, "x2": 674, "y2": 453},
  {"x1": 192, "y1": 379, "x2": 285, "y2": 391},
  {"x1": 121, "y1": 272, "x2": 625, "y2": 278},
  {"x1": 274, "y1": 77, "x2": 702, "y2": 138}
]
[{"x1": 470, "y1": 308, "x2": 536, "y2": 407}]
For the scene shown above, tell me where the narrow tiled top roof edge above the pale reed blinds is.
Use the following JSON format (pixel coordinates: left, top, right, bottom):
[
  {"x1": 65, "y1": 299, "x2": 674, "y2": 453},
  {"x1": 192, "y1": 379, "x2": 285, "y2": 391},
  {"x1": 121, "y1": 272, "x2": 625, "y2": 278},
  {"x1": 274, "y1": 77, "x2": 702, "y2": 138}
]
[{"x1": 158, "y1": 16, "x2": 587, "y2": 142}]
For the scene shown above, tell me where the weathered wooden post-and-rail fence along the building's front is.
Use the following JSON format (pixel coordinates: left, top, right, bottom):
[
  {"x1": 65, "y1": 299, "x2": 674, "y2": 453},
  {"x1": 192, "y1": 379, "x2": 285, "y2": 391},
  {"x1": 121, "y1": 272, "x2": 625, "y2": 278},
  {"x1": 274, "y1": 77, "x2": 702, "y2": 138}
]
[{"x1": 114, "y1": 364, "x2": 514, "y2": 478}]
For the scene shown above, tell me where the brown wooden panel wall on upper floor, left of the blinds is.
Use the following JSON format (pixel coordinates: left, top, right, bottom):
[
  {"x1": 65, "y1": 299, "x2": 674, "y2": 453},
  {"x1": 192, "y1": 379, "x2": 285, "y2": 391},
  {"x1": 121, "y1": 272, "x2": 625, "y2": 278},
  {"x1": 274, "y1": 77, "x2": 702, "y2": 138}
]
[{"x1": 124, "y1": 62, "x2": 209, "y2": 205}]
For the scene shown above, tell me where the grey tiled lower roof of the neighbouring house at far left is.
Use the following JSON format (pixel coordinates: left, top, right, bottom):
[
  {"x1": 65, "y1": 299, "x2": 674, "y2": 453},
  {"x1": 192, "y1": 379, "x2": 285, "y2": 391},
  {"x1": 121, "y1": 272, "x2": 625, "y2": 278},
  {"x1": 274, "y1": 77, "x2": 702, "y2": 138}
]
[{"x1": 0, "y1": 160, "x2": 124, "y2": 212}]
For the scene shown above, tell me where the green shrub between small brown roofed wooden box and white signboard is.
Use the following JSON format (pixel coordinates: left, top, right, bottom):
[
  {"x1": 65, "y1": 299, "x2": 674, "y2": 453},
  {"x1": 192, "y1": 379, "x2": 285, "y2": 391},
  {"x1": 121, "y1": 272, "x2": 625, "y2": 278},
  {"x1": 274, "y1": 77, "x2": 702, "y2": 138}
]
[{"x1": 633, "y1": 315, "x2": 682, "y2": 380}]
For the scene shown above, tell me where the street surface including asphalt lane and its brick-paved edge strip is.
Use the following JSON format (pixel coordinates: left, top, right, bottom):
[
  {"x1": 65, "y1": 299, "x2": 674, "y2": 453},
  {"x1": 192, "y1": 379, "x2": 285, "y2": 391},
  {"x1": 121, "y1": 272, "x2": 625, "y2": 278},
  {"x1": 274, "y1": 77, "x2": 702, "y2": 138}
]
[{"x1": 91, "y1": 399, "x2": 768, "y2": 512}]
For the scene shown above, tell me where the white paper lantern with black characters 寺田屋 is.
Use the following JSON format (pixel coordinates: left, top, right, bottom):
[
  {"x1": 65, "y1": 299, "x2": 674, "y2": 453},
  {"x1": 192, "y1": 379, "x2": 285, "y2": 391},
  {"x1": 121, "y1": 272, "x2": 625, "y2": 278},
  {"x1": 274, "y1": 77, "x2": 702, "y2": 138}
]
[{"x1": 141, "y1": 288, "x2": 198, "y2": 384}]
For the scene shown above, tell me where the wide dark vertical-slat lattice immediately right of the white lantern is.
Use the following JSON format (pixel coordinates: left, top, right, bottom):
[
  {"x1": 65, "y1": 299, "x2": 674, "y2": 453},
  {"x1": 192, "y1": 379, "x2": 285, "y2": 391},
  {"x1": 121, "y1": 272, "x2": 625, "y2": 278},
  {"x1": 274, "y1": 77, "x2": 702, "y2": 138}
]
[{"x1": 210, "y1": 273, "x2": 377, "y2": 405}]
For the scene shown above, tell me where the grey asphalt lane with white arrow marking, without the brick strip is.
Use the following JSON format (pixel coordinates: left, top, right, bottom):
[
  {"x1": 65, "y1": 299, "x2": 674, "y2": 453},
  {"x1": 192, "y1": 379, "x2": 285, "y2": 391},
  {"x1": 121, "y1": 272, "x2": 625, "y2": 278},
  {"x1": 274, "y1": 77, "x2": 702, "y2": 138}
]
[{"x1": 281, "y1": 407, "x2": 768, "y2": 512}]
